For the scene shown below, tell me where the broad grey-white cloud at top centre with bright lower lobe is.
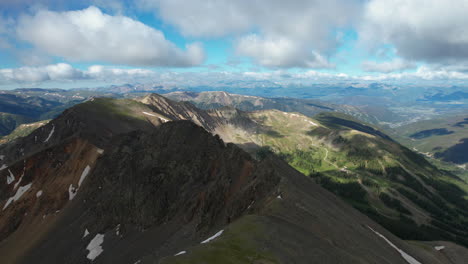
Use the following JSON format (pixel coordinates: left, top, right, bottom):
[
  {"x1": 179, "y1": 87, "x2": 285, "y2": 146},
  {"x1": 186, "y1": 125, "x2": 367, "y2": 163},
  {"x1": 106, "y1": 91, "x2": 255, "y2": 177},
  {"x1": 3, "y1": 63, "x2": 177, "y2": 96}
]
[{"x1": 138, "y1": 0, "x2": 361, "y2": 68}]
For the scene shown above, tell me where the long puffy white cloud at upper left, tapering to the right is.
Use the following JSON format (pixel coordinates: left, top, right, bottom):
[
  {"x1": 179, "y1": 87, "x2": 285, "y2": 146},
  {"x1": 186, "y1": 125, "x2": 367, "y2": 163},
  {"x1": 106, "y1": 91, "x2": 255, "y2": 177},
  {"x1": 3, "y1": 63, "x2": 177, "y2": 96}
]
[{"x1": 17, "y1": 6, "x2": 204, "y2": 67}]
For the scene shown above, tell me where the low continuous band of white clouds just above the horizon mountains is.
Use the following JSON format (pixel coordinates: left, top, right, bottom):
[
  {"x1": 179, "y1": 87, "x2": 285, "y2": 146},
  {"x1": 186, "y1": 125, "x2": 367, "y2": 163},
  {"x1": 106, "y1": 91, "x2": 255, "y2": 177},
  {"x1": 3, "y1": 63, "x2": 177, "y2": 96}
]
[{"x1": 0, "y1": 63, "x2": 468, "y2": 87}]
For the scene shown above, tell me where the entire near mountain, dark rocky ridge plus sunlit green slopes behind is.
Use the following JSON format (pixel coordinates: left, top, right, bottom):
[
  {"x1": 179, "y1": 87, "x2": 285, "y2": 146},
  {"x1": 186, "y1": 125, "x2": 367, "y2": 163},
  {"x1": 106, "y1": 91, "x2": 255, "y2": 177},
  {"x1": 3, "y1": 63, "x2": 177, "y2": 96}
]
[{"x1": 0, "y1": 94, "x2": 468, "y2": 263}]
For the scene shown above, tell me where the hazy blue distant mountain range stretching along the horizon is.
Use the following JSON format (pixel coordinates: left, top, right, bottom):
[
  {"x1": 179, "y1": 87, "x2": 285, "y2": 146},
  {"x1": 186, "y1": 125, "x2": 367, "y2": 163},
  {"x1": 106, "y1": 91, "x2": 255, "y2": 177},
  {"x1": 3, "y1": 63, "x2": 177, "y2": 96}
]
[{"x1": 0, "y1": 80, "x2": 468, "y2": 129}]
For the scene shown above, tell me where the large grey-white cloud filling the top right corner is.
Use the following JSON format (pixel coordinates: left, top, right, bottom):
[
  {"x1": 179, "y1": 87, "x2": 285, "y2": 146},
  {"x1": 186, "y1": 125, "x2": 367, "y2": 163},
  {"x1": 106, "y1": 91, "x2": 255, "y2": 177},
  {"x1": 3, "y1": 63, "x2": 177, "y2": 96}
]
[{"x1": 360, "y1": 0, "x2": 468, "y2": 62}]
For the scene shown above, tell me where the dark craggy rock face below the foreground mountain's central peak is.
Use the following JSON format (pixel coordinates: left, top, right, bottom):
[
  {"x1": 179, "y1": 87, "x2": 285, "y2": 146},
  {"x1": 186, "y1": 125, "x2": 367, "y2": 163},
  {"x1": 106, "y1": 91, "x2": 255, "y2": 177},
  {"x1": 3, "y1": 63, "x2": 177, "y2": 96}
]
[{"x1": 84, "y1": 121, "x2": 279, "y2": 233}]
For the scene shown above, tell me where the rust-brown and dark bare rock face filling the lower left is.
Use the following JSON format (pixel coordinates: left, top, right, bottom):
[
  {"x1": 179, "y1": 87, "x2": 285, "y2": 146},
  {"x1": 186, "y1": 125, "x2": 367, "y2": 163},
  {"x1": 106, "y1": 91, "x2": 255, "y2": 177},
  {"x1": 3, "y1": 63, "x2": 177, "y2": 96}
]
[{"x1": 0, "y1": 121, "x2": 280, "y2": 263}]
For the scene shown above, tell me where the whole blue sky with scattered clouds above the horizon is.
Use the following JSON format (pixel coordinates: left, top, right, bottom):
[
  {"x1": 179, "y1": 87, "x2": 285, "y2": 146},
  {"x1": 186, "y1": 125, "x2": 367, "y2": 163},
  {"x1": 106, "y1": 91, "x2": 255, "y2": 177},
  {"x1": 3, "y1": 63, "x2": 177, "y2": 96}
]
[{"x1": 0, "y1": 0, "x2": 468, "y2": 89}]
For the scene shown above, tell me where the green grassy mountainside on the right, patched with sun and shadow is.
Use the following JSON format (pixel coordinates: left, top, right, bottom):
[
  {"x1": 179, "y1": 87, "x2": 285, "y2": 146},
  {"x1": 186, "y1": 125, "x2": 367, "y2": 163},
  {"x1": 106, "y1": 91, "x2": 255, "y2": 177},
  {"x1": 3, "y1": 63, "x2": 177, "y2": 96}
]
[{"x1": 229, "y1": 110, "x2": 468, "y2": 248}]
